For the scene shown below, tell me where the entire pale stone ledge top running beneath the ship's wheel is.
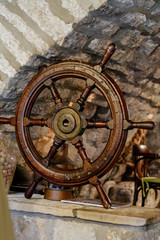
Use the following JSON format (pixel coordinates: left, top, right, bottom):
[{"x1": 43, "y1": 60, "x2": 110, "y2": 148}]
[{"x1": 8, "y1": 193, "x2": 160, "y2": 226}]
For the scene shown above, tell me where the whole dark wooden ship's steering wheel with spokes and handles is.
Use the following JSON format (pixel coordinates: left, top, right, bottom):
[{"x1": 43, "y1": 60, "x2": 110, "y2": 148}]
[{"x1": 0, "y1": 44, "x2": 154, "y2": 208}]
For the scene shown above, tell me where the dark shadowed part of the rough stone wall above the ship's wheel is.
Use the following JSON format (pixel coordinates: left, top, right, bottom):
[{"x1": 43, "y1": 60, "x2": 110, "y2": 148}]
[{"x1": 0, "y1": 0, "x2": 160, "y2": 150}]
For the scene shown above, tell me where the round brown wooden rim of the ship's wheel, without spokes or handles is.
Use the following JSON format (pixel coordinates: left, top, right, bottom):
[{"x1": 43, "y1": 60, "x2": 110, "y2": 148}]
[{"x1": 16, "y1": 61, "x2": 128, "y2": 186}]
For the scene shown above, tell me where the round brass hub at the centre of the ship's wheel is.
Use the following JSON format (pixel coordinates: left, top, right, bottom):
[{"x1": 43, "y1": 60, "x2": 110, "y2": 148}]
[{"x1": 53, "y1": 107, "x2": 82, "y2": 140}]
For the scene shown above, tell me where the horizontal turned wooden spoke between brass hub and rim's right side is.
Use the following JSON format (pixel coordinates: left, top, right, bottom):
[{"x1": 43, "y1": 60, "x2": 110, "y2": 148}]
[{"x1": 86, "y1": 119, "x2": 113, "y2": 130}]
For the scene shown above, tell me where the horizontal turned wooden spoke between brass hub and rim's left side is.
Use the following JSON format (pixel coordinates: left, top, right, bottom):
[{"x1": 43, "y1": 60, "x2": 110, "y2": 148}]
[{"x1": 23, "y1": 117, "x2": 52, "y2": 128}]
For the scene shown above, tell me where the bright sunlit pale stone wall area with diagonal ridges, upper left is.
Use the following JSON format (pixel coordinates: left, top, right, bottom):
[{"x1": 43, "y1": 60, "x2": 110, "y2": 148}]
[{"x1": 0, "y1": 0, "x2": 105, "y2": 88}]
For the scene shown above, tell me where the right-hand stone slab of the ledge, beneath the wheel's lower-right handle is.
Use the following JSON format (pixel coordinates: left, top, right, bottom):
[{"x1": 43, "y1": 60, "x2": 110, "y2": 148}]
[{"x1": 76, "y1": 207, "x2": 160, "y2": 227}]
